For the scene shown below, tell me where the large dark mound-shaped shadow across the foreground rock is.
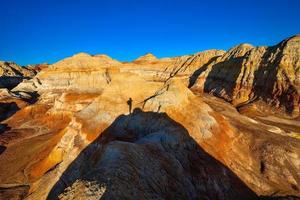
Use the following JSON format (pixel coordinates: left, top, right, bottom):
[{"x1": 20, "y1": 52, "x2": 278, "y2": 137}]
[{"x1": 47, "y1": 109, "x2": 257, "y2": 199}]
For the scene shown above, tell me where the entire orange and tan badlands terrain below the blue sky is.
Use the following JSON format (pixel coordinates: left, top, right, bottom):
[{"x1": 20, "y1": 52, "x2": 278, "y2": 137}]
[{"x1": 0, "y1": 35, "x2": 300, "y2": 200}]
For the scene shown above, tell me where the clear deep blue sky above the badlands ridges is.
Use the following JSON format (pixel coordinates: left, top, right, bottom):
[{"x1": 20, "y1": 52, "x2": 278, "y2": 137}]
[{"x1": 0, "y1": 0, "x2": 300, "y2": 65}]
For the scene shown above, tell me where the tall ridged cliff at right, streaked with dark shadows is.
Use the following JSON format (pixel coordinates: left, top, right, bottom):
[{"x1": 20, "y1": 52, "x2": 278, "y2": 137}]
[{"x1": 189, "y1": 36, "x2": 300, "y2": 116}]
